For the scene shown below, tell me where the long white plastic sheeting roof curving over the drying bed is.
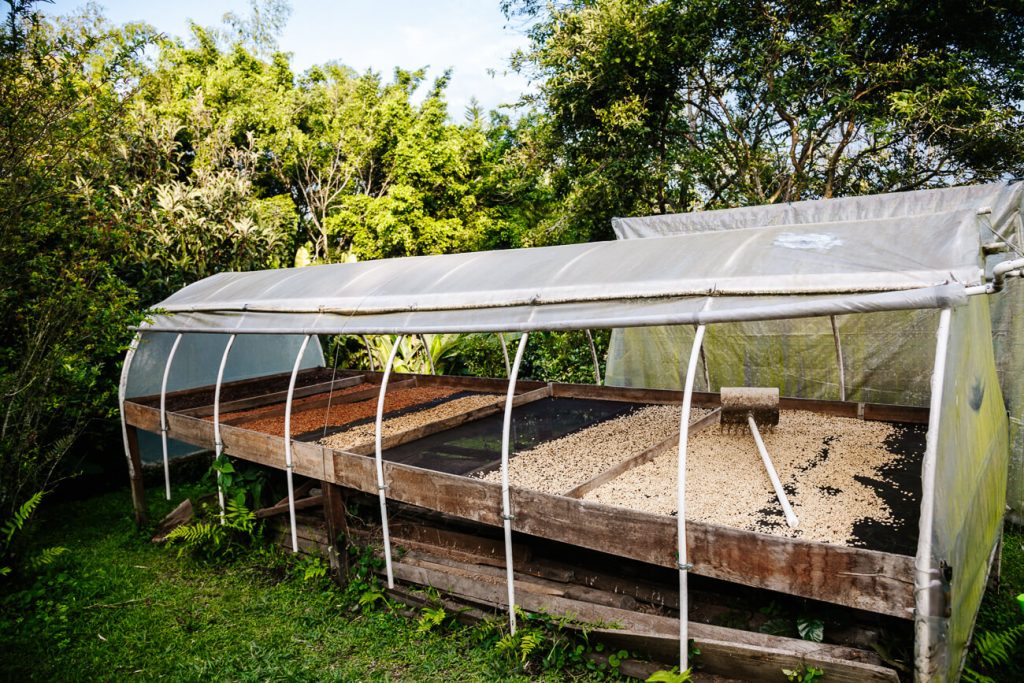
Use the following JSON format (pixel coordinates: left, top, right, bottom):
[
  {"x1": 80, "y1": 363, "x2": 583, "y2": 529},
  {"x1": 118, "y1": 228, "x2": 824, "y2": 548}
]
[{"x1": 140, "y1": 193, "x2": 984, "y2": 334}]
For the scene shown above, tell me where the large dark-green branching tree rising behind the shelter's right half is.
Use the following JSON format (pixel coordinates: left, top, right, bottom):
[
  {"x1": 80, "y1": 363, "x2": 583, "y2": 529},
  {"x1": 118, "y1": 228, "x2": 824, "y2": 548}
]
[{"x1": 506, "y1": 0, "x2": 1024, "y2": 240}]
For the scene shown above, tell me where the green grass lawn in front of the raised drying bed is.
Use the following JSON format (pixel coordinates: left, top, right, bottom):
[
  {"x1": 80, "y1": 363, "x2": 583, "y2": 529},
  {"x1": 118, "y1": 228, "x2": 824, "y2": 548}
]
[{"x1": 0, "y1": 483, "x2": 610, "y2": 681}]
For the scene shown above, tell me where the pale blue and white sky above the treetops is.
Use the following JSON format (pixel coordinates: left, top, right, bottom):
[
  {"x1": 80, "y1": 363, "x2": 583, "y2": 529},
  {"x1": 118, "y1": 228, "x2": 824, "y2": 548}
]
[{"x1": 43, "y1": 0, "x2": 529, "y2": 120}]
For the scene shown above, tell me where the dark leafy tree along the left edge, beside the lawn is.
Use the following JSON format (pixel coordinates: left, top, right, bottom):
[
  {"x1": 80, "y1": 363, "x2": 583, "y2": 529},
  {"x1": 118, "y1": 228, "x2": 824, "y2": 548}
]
[{"x1": 0, "y1": 0, "x2": 152, "y2": 512}]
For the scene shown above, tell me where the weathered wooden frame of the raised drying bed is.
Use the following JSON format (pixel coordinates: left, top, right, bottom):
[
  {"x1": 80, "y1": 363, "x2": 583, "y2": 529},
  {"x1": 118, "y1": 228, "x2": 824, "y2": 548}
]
[{"x1": 125, "y1": 373, "x2": 928, "y2": 618}]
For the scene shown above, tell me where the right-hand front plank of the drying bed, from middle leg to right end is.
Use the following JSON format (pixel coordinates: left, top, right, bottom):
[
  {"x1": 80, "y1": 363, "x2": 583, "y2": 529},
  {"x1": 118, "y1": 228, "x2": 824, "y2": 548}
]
[{"x1": 325, "y1": 451, "x2": 913, "y2": 618}]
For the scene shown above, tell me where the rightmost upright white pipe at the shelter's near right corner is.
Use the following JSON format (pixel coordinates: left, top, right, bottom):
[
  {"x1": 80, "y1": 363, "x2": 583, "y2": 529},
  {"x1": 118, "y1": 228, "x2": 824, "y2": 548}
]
[{"x1": 913, "y1": 308, "x2": 952, "y2": 681}]
